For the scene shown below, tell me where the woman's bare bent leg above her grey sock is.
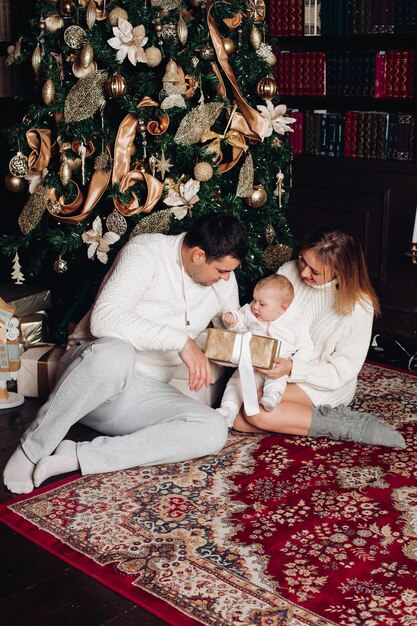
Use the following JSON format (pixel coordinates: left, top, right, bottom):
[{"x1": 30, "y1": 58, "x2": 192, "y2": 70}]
[{"x1": 233, "y1": 383, "x2": 313, "y2": 436}]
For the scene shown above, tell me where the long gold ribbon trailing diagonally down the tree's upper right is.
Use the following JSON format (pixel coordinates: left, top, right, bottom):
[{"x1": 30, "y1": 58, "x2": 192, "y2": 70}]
[{"x1": 207, "y1": 2, "x2": 268, "y2": 141}]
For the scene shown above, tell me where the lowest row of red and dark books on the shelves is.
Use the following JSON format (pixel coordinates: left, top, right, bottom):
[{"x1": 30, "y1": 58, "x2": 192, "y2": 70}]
[{"x1": 289, "y1": 110, "x2": 416, "y2": 162}]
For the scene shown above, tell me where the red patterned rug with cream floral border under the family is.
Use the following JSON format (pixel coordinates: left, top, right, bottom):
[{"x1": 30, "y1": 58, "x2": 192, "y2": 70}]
[{"x1": 0, "y1": 364, "x2": 417, "y2": 626}]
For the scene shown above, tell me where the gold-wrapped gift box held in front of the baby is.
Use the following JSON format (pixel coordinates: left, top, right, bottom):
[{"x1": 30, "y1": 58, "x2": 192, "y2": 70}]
[{"x1": 204, "y1": 328, "x2": 281, "y2": 369}]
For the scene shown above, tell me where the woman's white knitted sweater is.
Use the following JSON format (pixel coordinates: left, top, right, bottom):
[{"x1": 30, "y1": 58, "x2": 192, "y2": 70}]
[{"x1": 278, "y1": 261, "x2": 373, "y2": 406}]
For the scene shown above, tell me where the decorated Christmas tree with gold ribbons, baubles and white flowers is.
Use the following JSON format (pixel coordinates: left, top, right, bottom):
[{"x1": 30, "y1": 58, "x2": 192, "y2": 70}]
[{"x1": 0, "y1": 0, "x2": 294, "y2": 338}]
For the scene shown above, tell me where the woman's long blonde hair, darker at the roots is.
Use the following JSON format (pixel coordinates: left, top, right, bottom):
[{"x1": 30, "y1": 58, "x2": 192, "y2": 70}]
[{"x1": 301, "y1": 226, "x2": 380, "y2": 315}]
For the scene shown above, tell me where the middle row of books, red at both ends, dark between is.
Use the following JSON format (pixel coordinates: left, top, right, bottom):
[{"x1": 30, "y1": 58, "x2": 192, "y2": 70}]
[{"x1": 274, "y1": 50, "x2": 415, "y2": 99}]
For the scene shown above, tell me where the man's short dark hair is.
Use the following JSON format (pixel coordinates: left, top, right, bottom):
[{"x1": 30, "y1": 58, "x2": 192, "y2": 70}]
[{"x1": 184, "y1": 213, "x2": 248, "y2": 262}]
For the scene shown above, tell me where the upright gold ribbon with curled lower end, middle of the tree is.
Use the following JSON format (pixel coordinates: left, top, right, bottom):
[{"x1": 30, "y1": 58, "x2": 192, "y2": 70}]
[{"x1": 112, "y1": 96, "x2": 165, "y2": 217}]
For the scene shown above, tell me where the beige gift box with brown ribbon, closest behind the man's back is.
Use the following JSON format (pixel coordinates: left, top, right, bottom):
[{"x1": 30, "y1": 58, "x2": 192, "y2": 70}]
[{"x1": 17, "y1": 343, "x2": 65, "y2": 398}]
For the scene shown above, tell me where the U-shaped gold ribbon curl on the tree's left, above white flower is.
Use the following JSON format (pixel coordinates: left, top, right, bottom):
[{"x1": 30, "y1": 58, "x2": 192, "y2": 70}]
[{"x1": 46, "y1": 147, "x2": 111, "y2": 224}]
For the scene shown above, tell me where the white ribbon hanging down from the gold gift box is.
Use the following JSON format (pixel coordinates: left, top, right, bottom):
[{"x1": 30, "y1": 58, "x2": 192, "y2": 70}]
[{"x1": 230, "y1": 331, "x2": 259, "y2": 415}]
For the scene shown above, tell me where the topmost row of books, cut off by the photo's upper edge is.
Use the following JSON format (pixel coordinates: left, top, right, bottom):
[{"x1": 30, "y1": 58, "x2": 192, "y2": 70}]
[{"x1": 268, "y1": 0, "x2": 417, "y2": 37}]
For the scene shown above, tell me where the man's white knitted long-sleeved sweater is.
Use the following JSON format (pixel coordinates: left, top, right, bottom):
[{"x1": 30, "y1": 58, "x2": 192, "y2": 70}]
[{"x1": 69, "y1": 234, "x2": 239, "y2": 382}]
